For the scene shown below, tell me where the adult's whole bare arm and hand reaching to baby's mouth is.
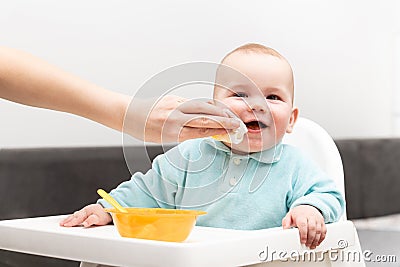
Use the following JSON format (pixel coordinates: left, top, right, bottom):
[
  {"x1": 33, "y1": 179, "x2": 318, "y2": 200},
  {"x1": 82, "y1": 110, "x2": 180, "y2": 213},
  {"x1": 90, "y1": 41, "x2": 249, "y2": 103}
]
[{"x1": 0, "y1": 47, "x2": 239, "y2": 142}]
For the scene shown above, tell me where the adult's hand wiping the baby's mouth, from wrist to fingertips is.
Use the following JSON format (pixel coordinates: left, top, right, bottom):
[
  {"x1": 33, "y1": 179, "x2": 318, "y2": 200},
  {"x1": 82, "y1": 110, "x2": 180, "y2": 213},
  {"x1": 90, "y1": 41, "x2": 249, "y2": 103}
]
[{"x1": 124, "y1": 95, "x2": 239, "y2": 143}]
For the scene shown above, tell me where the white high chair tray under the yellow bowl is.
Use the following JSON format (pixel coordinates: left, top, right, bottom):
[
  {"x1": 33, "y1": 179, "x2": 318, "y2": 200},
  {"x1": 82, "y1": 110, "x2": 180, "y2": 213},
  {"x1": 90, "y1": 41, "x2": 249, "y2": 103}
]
[{"x1": 0, "y1": 215, "x2": 355, "y2": 267}]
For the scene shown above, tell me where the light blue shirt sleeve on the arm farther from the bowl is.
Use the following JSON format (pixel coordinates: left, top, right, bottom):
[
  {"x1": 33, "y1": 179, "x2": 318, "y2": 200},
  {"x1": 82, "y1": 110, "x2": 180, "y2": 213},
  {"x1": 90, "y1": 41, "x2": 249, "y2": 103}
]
[{"x1": 288, "y1": 151, "x2": 345, "y2": 223}]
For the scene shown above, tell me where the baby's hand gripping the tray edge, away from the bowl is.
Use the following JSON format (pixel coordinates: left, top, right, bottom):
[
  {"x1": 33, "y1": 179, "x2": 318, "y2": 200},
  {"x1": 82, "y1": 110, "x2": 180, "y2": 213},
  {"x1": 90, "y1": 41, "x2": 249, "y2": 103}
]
[{"x1": 282, "y1": 205, "x2": 326, "y2": 249}]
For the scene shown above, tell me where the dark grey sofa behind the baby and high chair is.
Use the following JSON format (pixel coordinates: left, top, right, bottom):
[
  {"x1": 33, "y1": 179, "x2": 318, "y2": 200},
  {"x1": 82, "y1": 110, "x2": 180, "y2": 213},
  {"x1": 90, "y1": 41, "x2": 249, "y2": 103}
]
[{"x1": 0, "y1": 139, "x2": 400, "y2": 267}]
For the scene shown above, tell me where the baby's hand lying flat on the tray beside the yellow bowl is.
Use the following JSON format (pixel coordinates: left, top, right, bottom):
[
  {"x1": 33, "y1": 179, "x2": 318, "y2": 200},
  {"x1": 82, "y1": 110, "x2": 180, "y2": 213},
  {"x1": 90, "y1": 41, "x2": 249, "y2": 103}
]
[{"x1": 60, "y1": 204, "x2": 112, "y2": 227}]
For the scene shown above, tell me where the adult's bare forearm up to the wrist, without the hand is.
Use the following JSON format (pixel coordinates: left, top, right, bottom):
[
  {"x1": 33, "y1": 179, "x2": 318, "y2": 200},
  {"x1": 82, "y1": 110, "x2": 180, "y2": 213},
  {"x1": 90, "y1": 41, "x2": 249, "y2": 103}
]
[{"x1": 0, "y1": 47, "x2": 130, "y2": 131}]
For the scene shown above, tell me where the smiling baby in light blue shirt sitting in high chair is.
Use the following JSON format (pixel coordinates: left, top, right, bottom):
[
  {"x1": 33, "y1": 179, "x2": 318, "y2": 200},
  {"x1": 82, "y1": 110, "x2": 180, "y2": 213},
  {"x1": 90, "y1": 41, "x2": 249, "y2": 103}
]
[{"x1": 60, "y1": 44, "x2": 344, "y2": 251}]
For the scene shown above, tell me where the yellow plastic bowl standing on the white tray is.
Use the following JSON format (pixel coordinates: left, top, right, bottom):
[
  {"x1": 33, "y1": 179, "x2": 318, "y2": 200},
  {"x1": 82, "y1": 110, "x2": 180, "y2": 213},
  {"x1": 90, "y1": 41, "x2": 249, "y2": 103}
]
[{"x1": 105, "y1": 208, "x2": 206, "y2": 242}]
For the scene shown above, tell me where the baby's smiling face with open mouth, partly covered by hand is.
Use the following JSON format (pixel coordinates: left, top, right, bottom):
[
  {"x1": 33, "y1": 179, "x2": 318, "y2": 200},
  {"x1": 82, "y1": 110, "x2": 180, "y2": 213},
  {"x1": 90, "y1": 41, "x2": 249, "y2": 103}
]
[{"x1": 214, "y1": 52, "x2": 298, "y2": 153}]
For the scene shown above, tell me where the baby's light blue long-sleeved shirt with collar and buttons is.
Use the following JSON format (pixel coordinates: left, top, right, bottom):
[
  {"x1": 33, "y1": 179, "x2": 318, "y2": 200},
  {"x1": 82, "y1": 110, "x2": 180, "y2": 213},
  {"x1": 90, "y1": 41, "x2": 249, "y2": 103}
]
[{"x1": 98, "y1": 138, "x2": 345, "y2": 230}]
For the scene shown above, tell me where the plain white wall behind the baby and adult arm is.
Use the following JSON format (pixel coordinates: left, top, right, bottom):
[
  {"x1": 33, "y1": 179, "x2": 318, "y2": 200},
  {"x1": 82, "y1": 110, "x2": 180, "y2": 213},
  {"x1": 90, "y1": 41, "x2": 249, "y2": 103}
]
[{"x1": 0, "y1": 0, "x2": 400, "y2": 147}]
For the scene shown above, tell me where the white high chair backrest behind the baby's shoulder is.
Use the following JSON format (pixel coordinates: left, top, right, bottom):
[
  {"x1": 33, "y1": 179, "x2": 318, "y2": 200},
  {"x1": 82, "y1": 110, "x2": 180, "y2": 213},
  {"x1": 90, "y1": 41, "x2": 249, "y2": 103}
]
[{"x1": 283, "y1": 117, "x2": 346, "y2": 220}]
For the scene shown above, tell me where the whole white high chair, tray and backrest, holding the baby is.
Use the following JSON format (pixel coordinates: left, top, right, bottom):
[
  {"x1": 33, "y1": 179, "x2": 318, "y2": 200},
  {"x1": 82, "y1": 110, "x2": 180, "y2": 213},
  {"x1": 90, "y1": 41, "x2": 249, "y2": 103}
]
[{"x1": 0, "y1": 118, "x2": 365, "y2": 267}]
